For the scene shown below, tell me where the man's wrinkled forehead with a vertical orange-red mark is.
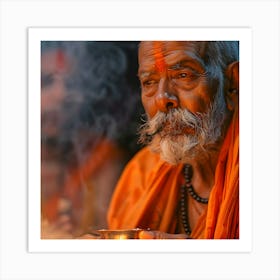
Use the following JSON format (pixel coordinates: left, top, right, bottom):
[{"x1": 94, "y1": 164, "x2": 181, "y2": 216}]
[{"x1": 138, "y1": 41, "x2": 206, "y2": 70}]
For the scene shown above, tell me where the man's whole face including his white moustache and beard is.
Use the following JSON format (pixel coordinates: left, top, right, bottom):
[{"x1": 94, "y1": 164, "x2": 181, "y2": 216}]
[{"x1": 138, "y1": 41, "x2": 226, "y2": 164}]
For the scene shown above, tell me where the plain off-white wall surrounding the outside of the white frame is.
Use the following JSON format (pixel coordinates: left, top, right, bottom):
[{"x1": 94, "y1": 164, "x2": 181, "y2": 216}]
[{"x1": 0, "y1": 0, "x2": 280, "y2": 280}]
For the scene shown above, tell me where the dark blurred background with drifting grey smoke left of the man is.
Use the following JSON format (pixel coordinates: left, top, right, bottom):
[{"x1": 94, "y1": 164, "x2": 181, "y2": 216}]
[{"x1": 41, "y1": 41, "x2": 144, "y2": 236}]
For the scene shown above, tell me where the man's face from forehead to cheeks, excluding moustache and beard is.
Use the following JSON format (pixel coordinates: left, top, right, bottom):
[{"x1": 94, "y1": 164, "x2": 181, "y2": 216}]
[{"x1": 138, "y1": 41, "x2": 216, "y2": 117}]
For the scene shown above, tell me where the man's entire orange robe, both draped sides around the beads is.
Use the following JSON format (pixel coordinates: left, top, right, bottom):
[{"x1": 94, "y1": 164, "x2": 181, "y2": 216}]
[{"x1": 108, "y1": 112, "x2": 239, "y2": 239}]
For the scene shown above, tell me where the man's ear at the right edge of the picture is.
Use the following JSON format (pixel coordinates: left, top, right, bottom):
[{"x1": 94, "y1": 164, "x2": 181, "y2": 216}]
[{"x1": 225, "y1": 61, "x2": 239, "y2": 111}]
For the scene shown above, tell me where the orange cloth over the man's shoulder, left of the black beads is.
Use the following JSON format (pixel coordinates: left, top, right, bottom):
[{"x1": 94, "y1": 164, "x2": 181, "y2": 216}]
[{"x1": 108, "y1": 147, "x2": 183, "y2": 232}]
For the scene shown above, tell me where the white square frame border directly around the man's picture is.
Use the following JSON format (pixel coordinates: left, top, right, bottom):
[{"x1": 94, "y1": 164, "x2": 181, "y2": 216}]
[{"x1": 28, "y1": 27, "x2": 252, "y2": 252}]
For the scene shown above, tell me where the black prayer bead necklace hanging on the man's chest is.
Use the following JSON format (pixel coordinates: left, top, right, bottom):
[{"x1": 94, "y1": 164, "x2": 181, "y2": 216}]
[{"x1": 180, "y1": 164, "x2": 208, "y2": 235}]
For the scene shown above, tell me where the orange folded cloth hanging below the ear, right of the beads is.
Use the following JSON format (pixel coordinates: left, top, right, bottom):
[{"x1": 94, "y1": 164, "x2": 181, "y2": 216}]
[{"x1": 192, "y1": 111, "x2": 239, "y2": 239}]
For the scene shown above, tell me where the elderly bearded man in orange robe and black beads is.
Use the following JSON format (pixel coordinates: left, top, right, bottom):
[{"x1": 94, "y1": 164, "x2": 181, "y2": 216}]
[{"x1": 108, "y1": 41, "x2": 239, "y2": 239}]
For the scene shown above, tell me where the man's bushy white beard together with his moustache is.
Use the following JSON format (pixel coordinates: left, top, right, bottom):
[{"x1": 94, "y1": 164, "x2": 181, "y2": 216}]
[{"x1": 139, "y1": 92, "x2": 229, "y2": 164}]
